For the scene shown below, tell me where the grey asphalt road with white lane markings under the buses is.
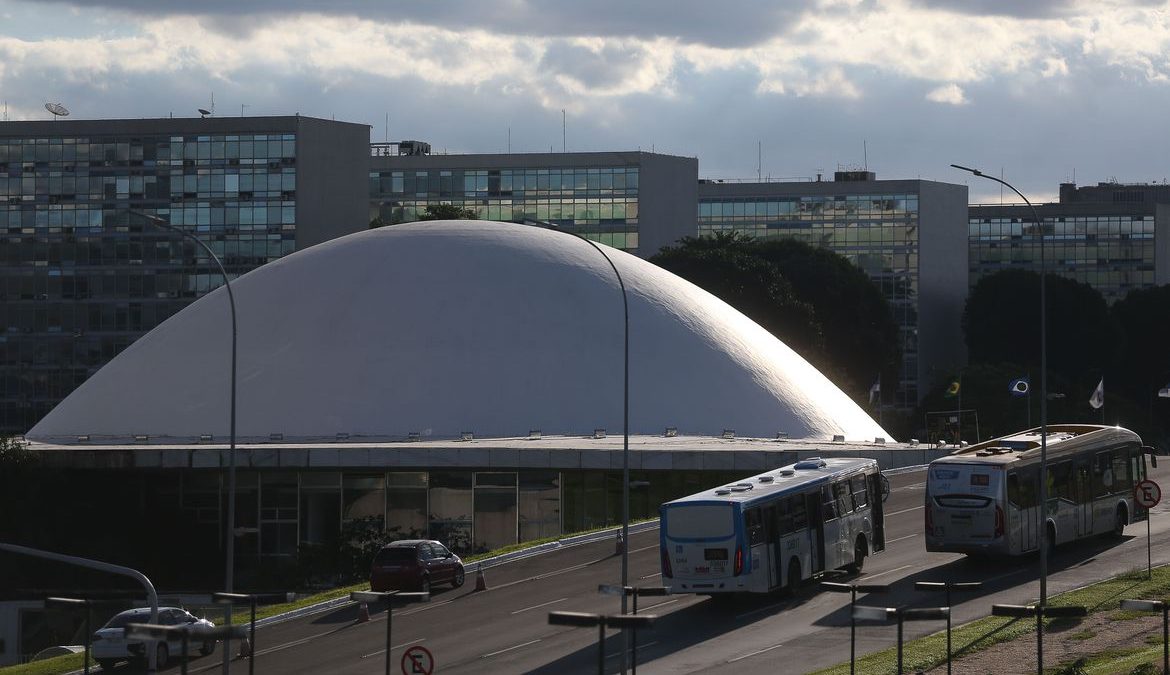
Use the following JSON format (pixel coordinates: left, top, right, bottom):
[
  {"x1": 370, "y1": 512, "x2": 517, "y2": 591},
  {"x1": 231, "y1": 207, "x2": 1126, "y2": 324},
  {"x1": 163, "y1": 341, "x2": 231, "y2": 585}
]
[{"x1": 153, "y1": 461, "x2": 1170, "y2": 675}]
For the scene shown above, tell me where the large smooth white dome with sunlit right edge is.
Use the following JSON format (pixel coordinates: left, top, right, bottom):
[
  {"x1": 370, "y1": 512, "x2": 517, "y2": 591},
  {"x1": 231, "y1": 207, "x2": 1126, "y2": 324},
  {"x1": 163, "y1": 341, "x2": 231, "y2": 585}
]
[{"x1": 27, "y1": 221, "x2": 889, "y2": 442}]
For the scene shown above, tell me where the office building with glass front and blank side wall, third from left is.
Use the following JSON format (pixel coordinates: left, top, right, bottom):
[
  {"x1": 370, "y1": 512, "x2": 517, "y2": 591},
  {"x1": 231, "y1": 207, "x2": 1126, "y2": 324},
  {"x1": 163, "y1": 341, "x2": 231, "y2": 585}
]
[{"x1": 698, "y1": 171, "x2": 968, "y2": 409}]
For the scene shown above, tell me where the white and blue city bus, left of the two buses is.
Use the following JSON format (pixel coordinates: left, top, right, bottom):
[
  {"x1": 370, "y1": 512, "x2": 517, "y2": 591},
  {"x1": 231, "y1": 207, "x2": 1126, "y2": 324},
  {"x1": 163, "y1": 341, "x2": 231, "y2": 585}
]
[{"x1": 659, "y1": 457, "x2": 888, "y2": 594}]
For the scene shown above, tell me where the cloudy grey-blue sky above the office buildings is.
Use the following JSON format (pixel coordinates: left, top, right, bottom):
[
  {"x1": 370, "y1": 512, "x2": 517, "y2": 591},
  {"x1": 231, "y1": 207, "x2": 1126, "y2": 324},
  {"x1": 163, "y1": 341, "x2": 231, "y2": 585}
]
[{"x1": 0, "y1": 0, "x2": 1170, "y2": 202}]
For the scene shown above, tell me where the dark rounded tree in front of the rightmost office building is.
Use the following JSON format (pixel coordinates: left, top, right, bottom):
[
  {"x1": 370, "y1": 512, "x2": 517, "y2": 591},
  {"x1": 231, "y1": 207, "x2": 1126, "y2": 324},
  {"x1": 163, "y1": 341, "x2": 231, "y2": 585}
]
[{"x1": 963, "y1": 270, "x2": 1116, "y2": 385}]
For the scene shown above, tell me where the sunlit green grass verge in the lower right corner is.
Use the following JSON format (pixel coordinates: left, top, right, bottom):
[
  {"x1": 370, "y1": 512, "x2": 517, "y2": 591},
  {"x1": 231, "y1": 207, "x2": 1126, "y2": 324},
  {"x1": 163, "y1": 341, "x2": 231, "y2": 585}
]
[{"x1": 814, "y1": 567, "x2": 1170, "y2": 675}]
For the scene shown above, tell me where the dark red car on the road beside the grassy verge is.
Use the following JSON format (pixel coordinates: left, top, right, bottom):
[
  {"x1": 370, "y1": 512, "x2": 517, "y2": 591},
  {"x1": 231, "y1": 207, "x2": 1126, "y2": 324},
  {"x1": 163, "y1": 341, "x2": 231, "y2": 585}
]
[{"x1": 370, "y1": 539, "x2": 466, "y2": 592}]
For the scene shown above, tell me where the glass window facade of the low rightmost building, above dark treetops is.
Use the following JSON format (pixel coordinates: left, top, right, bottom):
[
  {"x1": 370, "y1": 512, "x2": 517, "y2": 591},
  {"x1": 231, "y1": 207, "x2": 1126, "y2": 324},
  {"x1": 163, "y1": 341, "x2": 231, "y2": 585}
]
[{"x1": 968, "y1": 212, "x2": 1155, "y2": 303}]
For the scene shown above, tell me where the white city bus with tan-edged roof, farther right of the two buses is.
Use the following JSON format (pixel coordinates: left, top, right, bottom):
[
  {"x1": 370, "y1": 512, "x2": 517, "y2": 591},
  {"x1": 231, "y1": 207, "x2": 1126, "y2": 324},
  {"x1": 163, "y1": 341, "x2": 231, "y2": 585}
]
[{"x1": 924, "y1": 425, "x2": 1150, "y2": 556}]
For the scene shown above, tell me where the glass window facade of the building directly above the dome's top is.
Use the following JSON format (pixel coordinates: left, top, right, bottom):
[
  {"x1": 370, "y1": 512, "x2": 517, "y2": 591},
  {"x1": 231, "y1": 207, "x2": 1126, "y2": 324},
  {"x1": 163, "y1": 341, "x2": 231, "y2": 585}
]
[{"x1": 370, "y1": 166, "x2": 639, "y2": 252}]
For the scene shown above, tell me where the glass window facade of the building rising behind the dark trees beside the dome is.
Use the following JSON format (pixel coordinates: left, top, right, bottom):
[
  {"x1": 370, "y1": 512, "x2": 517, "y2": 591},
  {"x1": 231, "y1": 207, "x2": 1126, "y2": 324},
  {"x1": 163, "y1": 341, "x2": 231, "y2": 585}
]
[{"x1": 698, "y1": 193, "x2": 918, "y2": 408}]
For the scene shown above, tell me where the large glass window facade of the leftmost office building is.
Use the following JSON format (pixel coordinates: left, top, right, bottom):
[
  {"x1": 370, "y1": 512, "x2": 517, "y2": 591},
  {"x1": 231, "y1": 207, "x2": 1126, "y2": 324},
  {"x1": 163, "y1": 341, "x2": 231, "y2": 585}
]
[{"x1": 0, "y1": 133, "x2": 297, "y2": 433}]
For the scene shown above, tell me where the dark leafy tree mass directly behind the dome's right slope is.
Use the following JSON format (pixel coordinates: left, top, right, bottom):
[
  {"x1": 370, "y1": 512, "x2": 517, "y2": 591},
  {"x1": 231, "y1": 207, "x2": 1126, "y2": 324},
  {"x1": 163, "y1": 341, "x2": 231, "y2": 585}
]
[{"x1": 649, "y1": 233, "x2": 899, "y2": 402}]
